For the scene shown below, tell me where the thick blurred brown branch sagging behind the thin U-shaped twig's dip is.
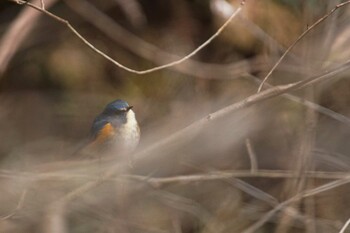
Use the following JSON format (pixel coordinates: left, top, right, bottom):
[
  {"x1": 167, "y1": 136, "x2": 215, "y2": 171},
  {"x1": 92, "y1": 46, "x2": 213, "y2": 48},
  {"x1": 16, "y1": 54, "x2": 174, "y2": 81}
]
[{"x1": 65, "y1": 0, "x2": 252, "y2": 79}]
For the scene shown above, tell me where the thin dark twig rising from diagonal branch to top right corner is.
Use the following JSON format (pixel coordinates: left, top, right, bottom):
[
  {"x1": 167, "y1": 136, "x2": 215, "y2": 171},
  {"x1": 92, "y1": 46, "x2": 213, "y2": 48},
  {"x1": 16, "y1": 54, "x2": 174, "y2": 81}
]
[{"x1": 258, "y1": 1, "x2": 350, "y2": 93}]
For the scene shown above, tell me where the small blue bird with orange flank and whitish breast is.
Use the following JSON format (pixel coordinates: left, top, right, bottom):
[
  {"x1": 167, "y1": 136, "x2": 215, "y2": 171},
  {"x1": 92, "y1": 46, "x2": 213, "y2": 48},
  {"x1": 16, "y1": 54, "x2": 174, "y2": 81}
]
[{"x1": 89, "y1": 100, "x2": 140, "y2": 154}]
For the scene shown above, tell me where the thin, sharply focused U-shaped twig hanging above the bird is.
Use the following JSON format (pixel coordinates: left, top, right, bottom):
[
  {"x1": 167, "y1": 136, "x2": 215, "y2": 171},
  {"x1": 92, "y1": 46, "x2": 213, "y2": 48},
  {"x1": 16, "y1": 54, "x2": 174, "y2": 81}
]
[{"x1": 9, "y1": 0, "x2": 244, "y2": 74}]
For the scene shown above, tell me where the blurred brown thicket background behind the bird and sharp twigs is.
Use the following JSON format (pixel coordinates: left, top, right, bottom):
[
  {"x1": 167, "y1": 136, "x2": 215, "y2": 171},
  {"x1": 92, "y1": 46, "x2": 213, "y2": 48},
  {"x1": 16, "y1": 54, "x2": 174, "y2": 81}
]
[{"x1": 0, "y1": 0, "x2": 350, "y2": 233}]
